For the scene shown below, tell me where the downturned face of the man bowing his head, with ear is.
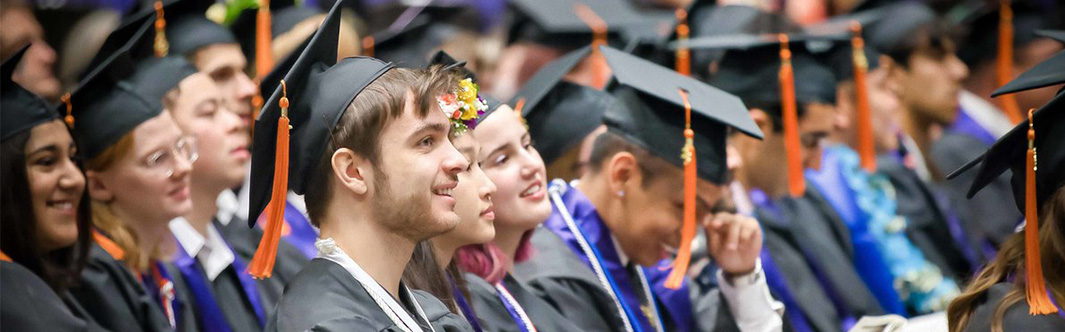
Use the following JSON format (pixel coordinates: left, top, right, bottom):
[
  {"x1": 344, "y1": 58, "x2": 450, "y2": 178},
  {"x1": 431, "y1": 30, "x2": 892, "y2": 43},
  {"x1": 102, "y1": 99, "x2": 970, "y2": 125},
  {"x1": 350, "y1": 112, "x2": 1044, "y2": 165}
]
[{"x1": 611, "y1": 156, "x2": 722, "y2": 266}]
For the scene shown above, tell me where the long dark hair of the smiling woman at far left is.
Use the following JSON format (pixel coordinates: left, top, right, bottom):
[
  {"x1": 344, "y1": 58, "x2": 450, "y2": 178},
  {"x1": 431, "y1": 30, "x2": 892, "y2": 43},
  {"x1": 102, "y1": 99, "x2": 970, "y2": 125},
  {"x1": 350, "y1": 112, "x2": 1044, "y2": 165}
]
[{"x1": 0, "y1": 131, "x2": 93, "y2": 293}]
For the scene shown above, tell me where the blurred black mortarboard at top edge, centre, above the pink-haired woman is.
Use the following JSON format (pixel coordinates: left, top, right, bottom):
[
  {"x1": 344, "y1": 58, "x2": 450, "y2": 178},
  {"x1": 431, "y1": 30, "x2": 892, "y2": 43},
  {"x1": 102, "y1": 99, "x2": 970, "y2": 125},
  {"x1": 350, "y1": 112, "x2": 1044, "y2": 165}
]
[{"x1": 507, "y1": 0, "x2": 648, "y2": 49}]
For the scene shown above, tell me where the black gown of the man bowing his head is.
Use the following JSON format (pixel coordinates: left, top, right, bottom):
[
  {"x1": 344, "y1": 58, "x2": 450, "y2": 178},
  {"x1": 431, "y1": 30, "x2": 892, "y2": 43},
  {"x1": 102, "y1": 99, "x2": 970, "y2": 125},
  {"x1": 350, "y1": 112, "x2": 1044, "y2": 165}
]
[{"x1": 508, "y1": 228, "x2": 738, "y2": 331}]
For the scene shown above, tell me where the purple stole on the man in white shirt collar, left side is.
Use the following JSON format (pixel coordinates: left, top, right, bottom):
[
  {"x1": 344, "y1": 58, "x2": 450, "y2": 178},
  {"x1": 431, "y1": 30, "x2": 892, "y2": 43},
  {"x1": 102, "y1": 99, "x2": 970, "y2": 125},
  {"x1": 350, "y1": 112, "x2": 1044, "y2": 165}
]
[{"x1": 174, "y1": 237, "x2": 266, "y2": 332}]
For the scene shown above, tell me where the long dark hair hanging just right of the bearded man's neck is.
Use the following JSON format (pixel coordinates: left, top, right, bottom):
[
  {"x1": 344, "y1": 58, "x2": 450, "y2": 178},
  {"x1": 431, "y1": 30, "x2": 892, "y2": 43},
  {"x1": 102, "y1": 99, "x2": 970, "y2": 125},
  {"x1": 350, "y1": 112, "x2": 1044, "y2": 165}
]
[{"x1": 403, "y1": 240, "x2": 470, "y2": 314}]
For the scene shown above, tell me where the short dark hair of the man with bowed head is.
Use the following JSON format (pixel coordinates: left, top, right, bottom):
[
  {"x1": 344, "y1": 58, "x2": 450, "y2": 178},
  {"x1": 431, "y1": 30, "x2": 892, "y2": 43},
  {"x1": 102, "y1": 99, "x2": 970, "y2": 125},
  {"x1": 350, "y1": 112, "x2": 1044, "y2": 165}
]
[{"x1": 588, "y1": 131, "x2": 681, "y2": 188}]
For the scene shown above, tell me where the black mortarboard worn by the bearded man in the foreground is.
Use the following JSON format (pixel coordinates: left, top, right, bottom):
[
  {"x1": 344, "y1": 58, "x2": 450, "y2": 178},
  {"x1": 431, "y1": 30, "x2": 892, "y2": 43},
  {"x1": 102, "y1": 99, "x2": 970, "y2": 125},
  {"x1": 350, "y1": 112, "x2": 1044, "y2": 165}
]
[{"x1": 248, "y1": 2, "x2": 394, "y2": 226}]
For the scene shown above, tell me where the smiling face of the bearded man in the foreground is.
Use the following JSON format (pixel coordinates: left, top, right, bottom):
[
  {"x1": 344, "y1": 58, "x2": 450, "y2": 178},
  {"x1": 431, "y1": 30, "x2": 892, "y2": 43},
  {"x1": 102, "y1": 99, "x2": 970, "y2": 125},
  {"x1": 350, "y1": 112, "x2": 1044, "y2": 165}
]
[{"x1": 372, "y1": 93, "x2": 470, "y2": 242}]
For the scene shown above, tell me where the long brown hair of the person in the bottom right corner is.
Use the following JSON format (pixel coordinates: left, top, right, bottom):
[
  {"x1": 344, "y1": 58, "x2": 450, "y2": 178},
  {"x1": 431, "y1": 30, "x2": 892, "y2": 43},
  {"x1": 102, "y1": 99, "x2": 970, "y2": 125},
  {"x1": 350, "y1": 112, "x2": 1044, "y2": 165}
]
[{"x1": 947, "y1": 186, "x2": 1065, "y2": 332}]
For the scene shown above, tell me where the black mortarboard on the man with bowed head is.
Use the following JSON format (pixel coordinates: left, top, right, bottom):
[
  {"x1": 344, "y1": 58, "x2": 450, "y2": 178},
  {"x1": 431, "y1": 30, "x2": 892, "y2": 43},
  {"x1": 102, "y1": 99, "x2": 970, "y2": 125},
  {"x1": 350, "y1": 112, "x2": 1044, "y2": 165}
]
[{"x1": 602, "y1": 47, "x2": 761, "y2": 183}]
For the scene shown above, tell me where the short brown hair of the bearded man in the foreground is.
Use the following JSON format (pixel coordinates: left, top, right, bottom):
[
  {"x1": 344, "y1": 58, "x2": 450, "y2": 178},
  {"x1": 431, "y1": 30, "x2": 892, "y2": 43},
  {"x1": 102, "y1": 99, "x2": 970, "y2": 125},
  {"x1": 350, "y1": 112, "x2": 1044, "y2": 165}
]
[{"x1": 306, "y1": 66, "x2": 461, "y2": 227}]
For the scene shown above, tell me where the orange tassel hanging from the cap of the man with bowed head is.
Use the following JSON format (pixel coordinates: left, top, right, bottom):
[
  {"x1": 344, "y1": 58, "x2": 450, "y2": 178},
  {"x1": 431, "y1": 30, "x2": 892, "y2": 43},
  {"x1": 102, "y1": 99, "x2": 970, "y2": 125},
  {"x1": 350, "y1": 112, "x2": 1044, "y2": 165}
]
[{"x1": 666, "y1": 88, "x2": 699, "y2": 289}]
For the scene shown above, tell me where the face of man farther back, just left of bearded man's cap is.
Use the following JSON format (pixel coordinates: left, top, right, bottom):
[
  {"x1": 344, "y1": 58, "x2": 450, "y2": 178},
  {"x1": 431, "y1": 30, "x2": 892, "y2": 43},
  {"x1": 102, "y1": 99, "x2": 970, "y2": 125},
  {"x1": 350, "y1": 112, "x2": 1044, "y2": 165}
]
[{"x1": 193, "y1": 44, "x2": 258, "y2": 126}]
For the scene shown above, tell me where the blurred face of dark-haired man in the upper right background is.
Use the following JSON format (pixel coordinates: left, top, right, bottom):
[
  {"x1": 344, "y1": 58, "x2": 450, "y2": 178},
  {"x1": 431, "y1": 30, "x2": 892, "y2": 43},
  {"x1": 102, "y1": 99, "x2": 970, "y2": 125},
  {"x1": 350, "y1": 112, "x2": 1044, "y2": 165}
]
[{"x1": 895, "y1": 47, "x2": 969, "y2": 125}]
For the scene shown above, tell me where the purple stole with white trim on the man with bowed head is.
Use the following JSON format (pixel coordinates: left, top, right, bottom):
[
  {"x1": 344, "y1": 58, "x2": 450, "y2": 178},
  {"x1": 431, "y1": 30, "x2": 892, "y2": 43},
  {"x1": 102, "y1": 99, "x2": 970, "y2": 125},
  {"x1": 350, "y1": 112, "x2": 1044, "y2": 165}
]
[{"x1": 547, "y1": 180, "x2": 663, "y2": 332}]
